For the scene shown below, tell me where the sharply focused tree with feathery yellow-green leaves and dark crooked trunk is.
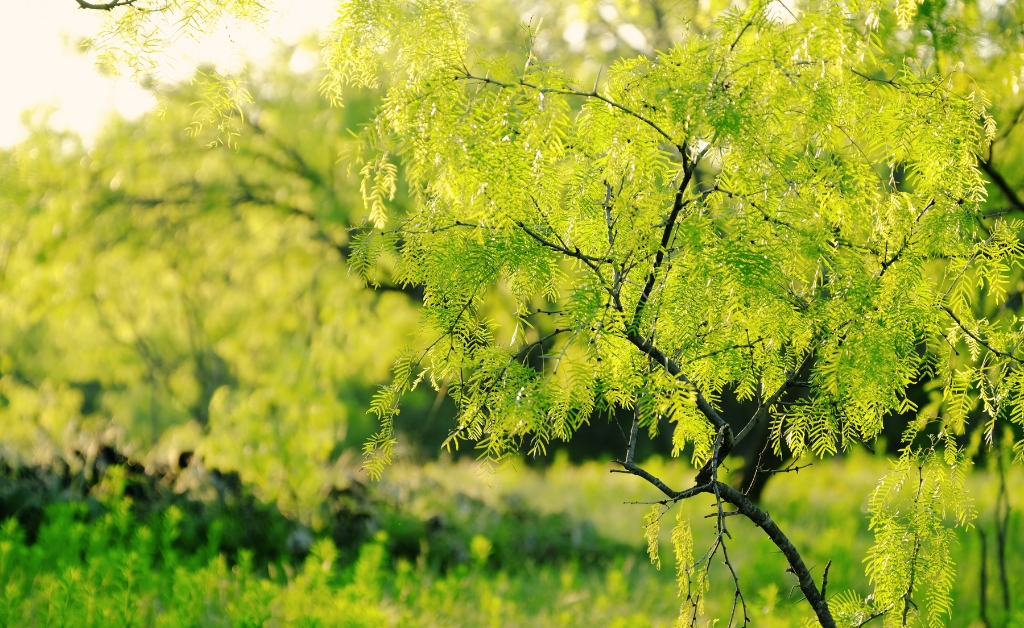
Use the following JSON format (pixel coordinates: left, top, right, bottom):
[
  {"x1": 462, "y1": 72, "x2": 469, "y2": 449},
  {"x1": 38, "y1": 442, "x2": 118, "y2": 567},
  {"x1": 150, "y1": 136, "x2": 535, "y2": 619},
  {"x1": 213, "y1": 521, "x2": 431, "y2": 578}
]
[{"x1": 66, "y1": 0, "x2": 1024, "y2": 626}]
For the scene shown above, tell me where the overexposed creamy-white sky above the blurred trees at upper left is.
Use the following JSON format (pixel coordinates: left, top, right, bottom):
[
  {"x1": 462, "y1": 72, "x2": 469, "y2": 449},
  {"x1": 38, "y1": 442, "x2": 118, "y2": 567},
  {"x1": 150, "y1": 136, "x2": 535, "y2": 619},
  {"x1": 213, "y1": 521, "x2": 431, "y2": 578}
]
[{"x1": 0, "y1": 0, "x2": 338, "y2": 148}]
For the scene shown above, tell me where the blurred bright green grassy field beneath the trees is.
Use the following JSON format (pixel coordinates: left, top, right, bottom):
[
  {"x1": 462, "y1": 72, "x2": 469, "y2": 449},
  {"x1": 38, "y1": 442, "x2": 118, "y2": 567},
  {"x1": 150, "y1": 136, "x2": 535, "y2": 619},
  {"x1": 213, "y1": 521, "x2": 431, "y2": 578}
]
[{"x1": 0, "y1": 455, "x2": 1024, "y2": 627}]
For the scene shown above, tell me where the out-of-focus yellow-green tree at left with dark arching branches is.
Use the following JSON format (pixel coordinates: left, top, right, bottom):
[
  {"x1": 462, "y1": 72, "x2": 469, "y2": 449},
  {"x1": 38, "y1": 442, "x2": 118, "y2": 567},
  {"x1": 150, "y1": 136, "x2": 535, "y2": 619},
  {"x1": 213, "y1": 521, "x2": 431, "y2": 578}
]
[{"x1": 0, "y1": 49, "x2": 416, "y2": 508}]
